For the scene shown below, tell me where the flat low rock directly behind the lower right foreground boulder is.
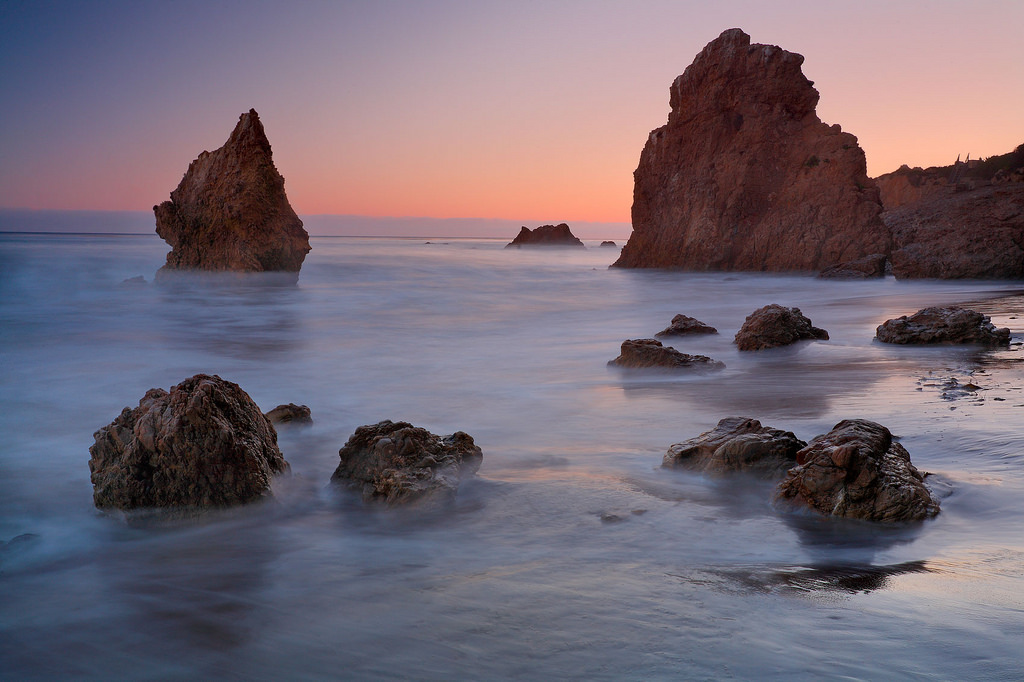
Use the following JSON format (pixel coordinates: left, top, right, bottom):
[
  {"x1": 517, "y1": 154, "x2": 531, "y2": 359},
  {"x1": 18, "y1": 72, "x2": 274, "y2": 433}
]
[{"x1": 664, "y1": 417, "x2": 807, "y2": 475}]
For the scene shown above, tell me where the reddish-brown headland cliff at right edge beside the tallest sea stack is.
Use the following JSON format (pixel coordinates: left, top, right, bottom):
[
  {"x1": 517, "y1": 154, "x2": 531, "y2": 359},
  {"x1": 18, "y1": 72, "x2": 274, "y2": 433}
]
[{"x1": 877, "y1": 144, "x2": 1024, "y2": 280}]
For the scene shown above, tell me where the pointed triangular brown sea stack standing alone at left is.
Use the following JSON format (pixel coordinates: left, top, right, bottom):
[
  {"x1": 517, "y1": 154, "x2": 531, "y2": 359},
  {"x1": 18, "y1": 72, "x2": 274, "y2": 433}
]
[{"x1": 153, "y1": 109, "x2": 309, "y2": 272}]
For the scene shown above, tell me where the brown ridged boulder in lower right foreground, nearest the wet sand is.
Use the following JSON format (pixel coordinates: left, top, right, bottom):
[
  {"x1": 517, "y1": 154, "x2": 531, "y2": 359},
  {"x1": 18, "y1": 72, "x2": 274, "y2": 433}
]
[{"x1": 775, "y1": 419, "x2": 939, "y2": 521}]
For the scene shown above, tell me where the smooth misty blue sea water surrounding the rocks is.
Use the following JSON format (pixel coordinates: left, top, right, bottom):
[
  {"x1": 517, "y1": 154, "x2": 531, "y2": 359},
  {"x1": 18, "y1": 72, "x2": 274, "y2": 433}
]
[{"x1": 6, "y1": 235, "x2": 1024, "y2": 680}]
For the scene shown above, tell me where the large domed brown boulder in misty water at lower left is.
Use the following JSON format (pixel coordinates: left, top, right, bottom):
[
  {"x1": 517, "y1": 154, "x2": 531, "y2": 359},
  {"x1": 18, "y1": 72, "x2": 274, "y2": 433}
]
[{"x1": 89, "y1": 374, "x2": 289, "y2": 510}]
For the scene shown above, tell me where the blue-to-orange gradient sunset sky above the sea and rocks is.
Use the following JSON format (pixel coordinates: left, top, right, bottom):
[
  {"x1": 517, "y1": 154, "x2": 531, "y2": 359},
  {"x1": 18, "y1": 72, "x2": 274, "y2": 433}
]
[{"x1": 0, "y1": 0, "x2": 1024, "y2": 229}]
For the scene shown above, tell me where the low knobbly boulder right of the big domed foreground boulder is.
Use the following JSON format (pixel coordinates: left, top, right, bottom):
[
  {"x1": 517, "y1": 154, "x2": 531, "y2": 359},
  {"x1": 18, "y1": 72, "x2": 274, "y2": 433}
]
[{"x1": 331, "y1": 421, "x2": 483, "y2": 504}]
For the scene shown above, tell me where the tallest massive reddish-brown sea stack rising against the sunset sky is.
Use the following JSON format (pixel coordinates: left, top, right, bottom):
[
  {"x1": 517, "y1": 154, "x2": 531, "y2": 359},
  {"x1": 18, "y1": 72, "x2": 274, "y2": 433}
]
[{"x1": 614, "y1": 29, "x2": 890, "y2": 271}]
